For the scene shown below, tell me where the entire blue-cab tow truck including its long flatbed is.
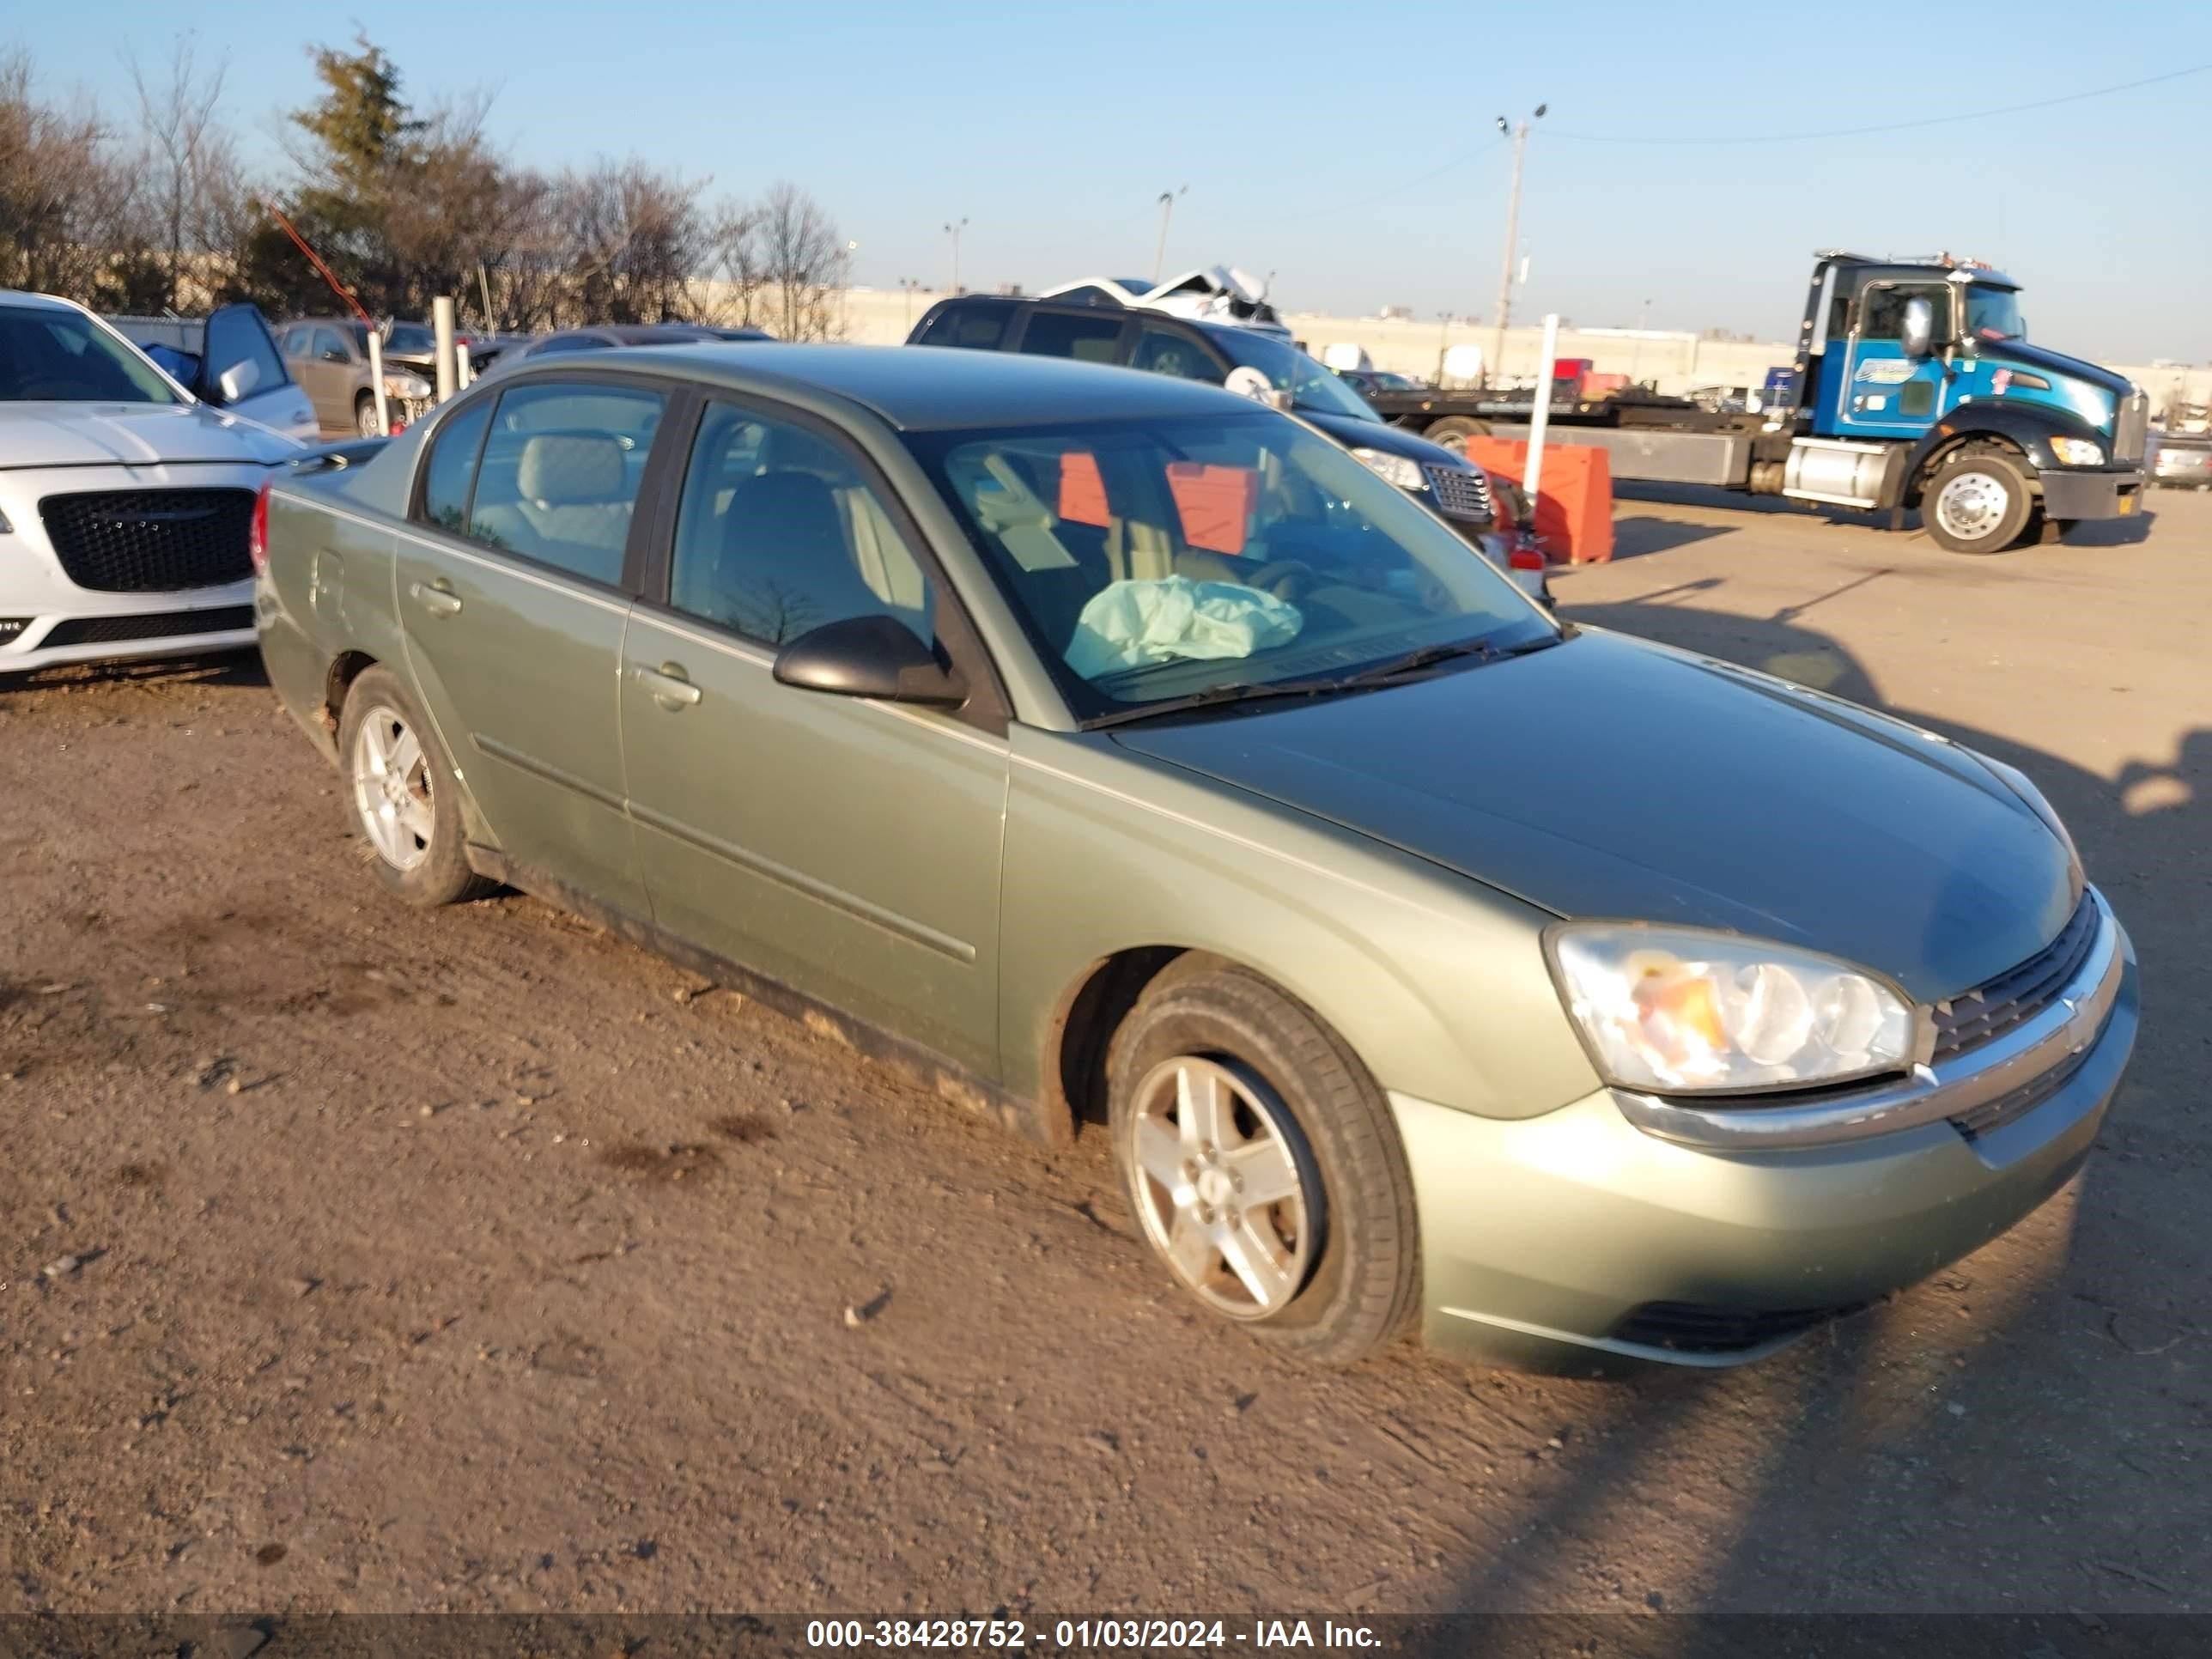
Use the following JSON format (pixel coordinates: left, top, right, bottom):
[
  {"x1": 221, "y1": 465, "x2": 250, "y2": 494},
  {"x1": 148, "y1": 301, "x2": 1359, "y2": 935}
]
[{"x1": 1371, "y1": 248, "x2": 2150, "y2": 553}]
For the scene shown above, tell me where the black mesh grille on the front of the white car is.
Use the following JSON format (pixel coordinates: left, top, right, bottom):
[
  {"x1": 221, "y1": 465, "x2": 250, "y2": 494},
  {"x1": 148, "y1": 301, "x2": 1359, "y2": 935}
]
[{"x1": 38, "y1": 489, "x2": 254, "y2": 592}]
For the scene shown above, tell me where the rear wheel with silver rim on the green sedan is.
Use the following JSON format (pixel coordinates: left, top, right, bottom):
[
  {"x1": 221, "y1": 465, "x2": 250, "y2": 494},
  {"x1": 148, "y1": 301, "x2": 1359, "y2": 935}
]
[{"x1": 338, "y1": 665, "x2": 493, "y2": 909}]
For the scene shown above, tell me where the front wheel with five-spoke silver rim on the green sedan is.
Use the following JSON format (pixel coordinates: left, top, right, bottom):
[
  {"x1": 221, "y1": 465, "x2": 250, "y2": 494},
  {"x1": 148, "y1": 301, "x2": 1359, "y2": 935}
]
[{"x1": 1106, "y1": 956, "x2": 1420, "y2": 1364}]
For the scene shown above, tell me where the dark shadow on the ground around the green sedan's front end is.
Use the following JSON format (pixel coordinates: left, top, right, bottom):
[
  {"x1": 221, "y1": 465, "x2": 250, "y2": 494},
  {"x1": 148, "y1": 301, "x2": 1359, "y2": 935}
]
[{"x1": 1455, "y1": 597, "x2": 2212, "y2": 1627}]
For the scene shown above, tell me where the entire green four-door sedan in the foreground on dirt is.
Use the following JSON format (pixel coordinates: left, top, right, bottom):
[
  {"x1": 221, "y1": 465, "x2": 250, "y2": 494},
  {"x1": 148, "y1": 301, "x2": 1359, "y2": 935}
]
[{"x1": 254, "y1": 345, "x2": 2136, "y2": 1364}]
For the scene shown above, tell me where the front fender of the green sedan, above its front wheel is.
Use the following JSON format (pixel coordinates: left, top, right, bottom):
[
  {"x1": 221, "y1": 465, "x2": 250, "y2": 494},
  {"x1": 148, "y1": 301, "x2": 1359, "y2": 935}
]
[{"x1": 1000, "y1": 726, "x2": 1597, "y2": 1117}]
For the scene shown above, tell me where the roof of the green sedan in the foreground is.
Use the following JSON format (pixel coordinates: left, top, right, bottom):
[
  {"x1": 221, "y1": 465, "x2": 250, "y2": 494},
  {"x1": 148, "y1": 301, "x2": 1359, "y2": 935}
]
[{"x1": 579, "y1": 343, "x2": 1252, "y2": 431}]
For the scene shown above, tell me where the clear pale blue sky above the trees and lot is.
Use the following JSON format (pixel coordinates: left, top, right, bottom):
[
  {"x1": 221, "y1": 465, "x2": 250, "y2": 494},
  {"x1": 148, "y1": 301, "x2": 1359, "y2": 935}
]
[{"x1": 21, "y1": 0, "x2": 2212, "y2": 362}]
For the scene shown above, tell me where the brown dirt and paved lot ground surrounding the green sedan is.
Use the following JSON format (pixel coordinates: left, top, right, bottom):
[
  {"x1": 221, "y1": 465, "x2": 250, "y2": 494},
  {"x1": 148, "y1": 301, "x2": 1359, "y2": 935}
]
[{"x1": 0, "y1": 493, "x2": 2212, "y2": 1614}]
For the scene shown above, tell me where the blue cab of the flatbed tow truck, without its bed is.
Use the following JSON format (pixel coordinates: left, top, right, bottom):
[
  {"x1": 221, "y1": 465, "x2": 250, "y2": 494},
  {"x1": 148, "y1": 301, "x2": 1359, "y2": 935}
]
[{"x1": 1787, "y1": 250, "x2": 2150, "y2": 553}]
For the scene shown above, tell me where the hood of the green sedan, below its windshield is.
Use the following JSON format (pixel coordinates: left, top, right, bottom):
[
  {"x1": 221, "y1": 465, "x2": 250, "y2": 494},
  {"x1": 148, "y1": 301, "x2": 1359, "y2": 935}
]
[{"x1": 1115, "y1": 630, "x2": 2079, "y2": 1002}]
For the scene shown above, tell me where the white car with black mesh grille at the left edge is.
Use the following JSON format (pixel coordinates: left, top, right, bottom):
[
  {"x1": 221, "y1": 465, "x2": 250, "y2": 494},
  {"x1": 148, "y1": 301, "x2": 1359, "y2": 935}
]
[{"x1": 0, "y1": 289, "x2": 305, "y2": 675}]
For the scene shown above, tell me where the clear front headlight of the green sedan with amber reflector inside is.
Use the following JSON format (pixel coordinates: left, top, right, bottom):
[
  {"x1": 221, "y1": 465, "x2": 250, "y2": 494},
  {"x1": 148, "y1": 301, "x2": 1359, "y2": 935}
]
[{"x1": 1547, "y1": 922, "x2": 1916, "y2": 1095}]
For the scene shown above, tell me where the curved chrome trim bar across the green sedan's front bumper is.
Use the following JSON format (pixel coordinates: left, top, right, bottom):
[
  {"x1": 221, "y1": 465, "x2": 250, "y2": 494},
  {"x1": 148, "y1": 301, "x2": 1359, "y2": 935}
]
[{"x1": 1610, "y1": 887, "x2": 2128, "y2": 1152}]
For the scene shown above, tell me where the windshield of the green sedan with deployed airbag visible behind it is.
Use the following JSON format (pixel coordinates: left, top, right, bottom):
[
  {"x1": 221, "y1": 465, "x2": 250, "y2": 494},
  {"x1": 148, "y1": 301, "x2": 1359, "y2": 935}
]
[{"x1": 907, "y1": 410, "x2": 1558, "y2": 719}]
